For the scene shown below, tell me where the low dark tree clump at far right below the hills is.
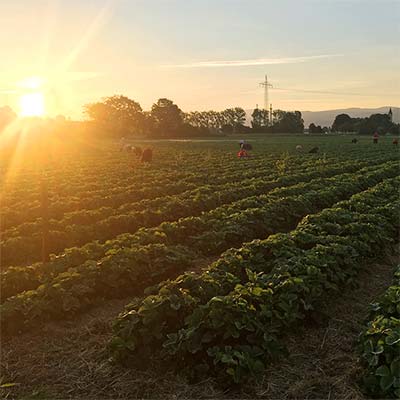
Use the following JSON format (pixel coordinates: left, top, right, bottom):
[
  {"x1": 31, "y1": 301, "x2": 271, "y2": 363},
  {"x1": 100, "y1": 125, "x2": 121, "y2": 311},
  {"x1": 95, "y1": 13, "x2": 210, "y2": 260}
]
[{"x1": 332, "y1": 114, "x2": 400, "y2": 135}]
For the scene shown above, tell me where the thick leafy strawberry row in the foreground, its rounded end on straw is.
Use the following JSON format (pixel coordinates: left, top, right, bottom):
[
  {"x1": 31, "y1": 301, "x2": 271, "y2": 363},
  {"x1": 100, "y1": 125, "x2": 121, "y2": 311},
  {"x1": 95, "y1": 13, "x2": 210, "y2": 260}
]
[{"x1": 110, "y1": 179, "x2": 400, "y2": 382}]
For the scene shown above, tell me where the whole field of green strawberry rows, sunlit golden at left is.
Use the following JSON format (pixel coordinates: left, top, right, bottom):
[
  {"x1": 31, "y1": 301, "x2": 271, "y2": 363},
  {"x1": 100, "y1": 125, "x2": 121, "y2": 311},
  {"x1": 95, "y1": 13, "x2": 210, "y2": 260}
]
[{"x1": 0, "y1": 136, "x2": 400, "y2": 398}]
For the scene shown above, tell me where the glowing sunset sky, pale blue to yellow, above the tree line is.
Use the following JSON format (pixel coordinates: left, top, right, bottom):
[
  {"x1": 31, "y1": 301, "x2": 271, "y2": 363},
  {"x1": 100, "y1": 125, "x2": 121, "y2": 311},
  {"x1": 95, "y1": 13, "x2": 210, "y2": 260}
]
[{"x1": 0, "y1": 0, "x2": 400, "y2": 118}]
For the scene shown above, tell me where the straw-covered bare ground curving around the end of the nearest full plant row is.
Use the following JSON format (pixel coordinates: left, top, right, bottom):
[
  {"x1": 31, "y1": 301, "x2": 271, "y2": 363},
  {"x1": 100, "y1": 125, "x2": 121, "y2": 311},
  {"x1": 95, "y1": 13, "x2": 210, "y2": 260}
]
[{"x1": 0, "y1": 256, "x2": 399, "y2": 399}]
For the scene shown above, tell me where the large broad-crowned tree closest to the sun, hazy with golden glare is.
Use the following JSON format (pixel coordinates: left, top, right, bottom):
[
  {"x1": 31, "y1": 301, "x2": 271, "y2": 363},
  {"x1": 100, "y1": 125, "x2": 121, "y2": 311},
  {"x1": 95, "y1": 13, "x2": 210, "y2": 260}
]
[{"x1": 84, "y1": 96, "x2": 143, "y2": 136}]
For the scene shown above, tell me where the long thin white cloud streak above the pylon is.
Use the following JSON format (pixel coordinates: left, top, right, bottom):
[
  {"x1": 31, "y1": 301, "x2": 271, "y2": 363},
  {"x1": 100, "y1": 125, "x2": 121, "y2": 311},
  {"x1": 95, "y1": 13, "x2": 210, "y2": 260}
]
[{"x1": 162, "y1": 54, "x2": 343, "y2": 68}]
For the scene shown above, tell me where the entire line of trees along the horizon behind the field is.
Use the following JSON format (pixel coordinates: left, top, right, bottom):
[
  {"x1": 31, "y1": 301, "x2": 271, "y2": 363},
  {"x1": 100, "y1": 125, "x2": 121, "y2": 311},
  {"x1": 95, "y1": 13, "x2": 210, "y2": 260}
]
[{"x1": 0, "y1": 95, "x2": 394, "y2": 138}]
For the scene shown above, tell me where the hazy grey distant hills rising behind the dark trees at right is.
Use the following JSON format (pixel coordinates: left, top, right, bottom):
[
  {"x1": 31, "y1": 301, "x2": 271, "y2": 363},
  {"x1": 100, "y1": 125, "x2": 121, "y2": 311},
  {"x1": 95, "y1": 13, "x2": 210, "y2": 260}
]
[{"x1": 246, "y1": 106, "x2": 400, "y2": 128}]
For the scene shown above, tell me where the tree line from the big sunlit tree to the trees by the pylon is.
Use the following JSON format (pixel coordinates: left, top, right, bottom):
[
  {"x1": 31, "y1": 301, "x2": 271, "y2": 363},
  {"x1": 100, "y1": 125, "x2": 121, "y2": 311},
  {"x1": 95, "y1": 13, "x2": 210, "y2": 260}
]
[{"x1": 84, "y1": 95, "x2": 304, "y2": 138}]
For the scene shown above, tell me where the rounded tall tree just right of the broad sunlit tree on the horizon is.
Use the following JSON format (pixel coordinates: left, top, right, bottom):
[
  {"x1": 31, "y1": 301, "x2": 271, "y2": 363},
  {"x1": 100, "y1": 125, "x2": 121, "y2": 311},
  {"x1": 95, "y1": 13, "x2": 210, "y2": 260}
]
[{"x1": 151, "y1": 98, "x2": 183, "y2": 137}]
